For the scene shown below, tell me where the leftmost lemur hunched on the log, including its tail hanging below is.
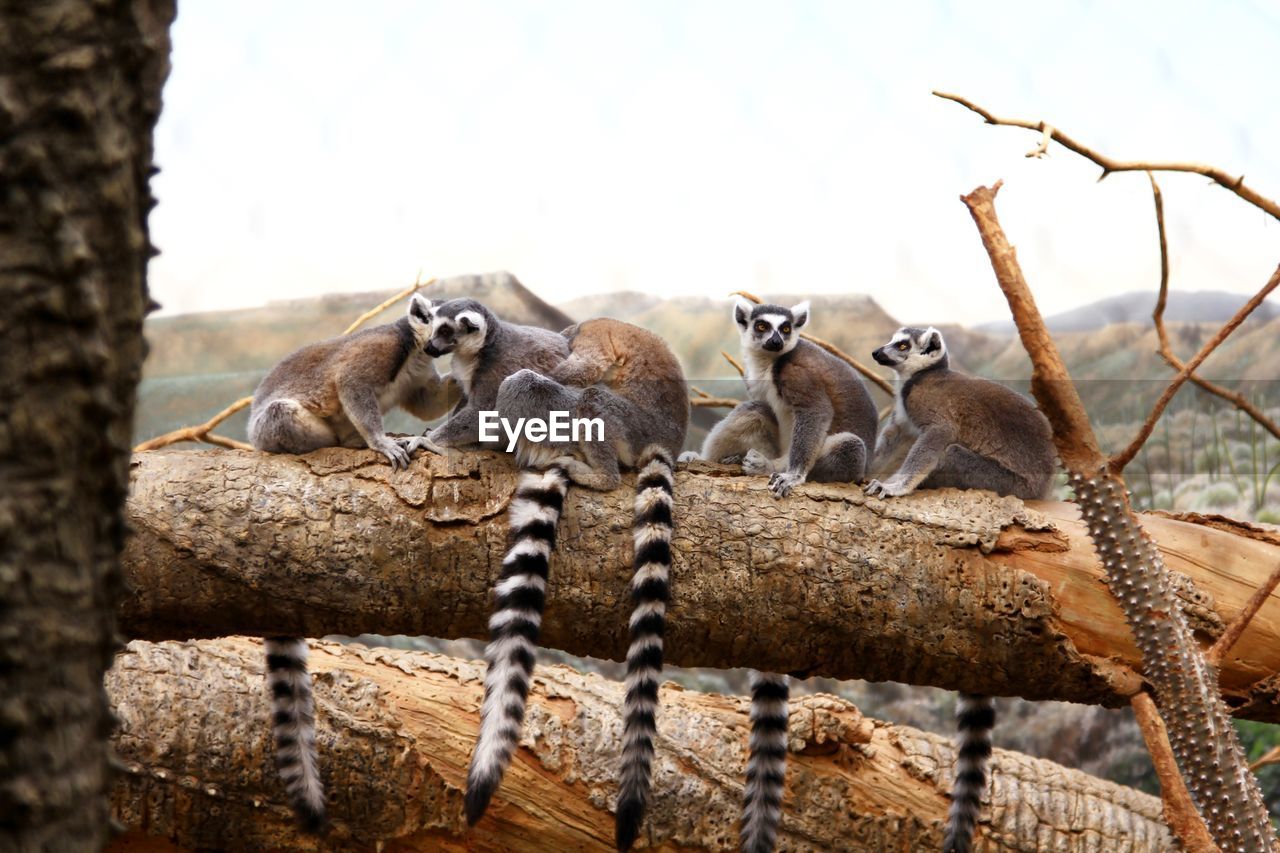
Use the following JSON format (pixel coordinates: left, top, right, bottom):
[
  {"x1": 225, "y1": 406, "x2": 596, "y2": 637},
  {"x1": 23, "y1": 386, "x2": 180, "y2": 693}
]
[{"x1": 248, "y1": 295, "x2": 448, "y2": 831}]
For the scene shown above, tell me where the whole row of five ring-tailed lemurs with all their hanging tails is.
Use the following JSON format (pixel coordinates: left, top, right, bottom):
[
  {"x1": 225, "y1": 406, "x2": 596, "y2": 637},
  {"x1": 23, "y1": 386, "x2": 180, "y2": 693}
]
[{"x1": 248, "y1": 286, "x2": 1056, "y2": 853}]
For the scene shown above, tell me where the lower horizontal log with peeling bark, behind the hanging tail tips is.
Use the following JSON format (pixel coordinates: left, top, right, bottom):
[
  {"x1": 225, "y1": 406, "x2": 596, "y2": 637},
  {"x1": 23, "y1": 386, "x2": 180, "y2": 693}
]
[{"x1": 108, "y1": 638, "x2": 1171, "y2": 852}]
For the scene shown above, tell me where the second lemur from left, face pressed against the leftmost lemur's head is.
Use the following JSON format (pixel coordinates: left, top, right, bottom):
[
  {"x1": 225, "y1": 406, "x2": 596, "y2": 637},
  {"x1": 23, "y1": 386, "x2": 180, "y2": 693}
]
[{"x1": 401, "y1": 298, "x2": 568, "y2": 453}]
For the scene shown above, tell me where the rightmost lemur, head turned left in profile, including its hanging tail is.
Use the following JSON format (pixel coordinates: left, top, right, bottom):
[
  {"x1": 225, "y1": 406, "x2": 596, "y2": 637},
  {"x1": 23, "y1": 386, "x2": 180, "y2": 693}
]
[{"x1": 867, "y1": 327, "x2": 1056, "y2": 853}]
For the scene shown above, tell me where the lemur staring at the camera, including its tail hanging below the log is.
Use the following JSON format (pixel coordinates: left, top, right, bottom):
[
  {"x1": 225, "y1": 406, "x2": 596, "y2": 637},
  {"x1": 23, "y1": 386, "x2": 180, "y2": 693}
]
[{"x1": 681, "y1": 298, "x2": 878, "y2": 853}]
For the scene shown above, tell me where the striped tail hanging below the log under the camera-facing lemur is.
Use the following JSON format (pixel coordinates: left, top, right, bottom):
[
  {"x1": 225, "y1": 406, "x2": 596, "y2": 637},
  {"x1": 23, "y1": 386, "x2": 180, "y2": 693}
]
[{"x1": 741, "y1": 672, "x2": 791, "y2": 853}]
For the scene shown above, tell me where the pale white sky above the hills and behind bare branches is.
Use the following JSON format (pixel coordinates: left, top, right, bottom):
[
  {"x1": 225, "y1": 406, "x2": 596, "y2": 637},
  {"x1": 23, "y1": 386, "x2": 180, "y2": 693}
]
[{"x1": 151, "y1": 0, "x2": 1280, "y2": 323}]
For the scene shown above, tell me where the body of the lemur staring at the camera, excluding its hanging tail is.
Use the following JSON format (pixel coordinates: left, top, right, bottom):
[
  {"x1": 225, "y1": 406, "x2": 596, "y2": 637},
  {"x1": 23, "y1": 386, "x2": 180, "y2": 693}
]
[{"x1": 685, "y1": 301, "x2": 878, "y2": 498}]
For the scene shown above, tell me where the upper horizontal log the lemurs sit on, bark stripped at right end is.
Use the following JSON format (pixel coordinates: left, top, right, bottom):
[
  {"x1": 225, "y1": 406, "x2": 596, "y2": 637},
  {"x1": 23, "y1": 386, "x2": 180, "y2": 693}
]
[{"x1": 122, "y1": 450, "x2": 1280, "y2": 721}]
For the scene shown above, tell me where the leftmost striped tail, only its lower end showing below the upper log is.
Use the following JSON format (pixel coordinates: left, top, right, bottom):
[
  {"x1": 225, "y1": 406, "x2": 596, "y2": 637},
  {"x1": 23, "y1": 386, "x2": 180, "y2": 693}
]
[{"x1": 264, "y1": 637, "x2": 325, "y2": 833}]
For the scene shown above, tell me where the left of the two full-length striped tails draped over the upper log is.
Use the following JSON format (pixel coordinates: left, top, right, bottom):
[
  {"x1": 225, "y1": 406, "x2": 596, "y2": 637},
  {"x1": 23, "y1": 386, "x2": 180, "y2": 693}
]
[{"x1": 465, "y1": 467, "x2": 568, "y2": 824}]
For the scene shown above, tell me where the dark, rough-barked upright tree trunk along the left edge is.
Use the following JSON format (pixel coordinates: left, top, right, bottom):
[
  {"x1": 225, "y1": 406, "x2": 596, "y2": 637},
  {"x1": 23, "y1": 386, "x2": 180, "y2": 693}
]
[{"x1": 0, "y1": 0, "x2": 174, "y2": 850}]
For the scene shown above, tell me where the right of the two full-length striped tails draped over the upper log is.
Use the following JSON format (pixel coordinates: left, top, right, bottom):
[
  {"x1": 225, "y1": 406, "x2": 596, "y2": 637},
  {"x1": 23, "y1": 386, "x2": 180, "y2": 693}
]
[{"x1": 616, "y1": 444, "x2": 676, "y2": 850}]
